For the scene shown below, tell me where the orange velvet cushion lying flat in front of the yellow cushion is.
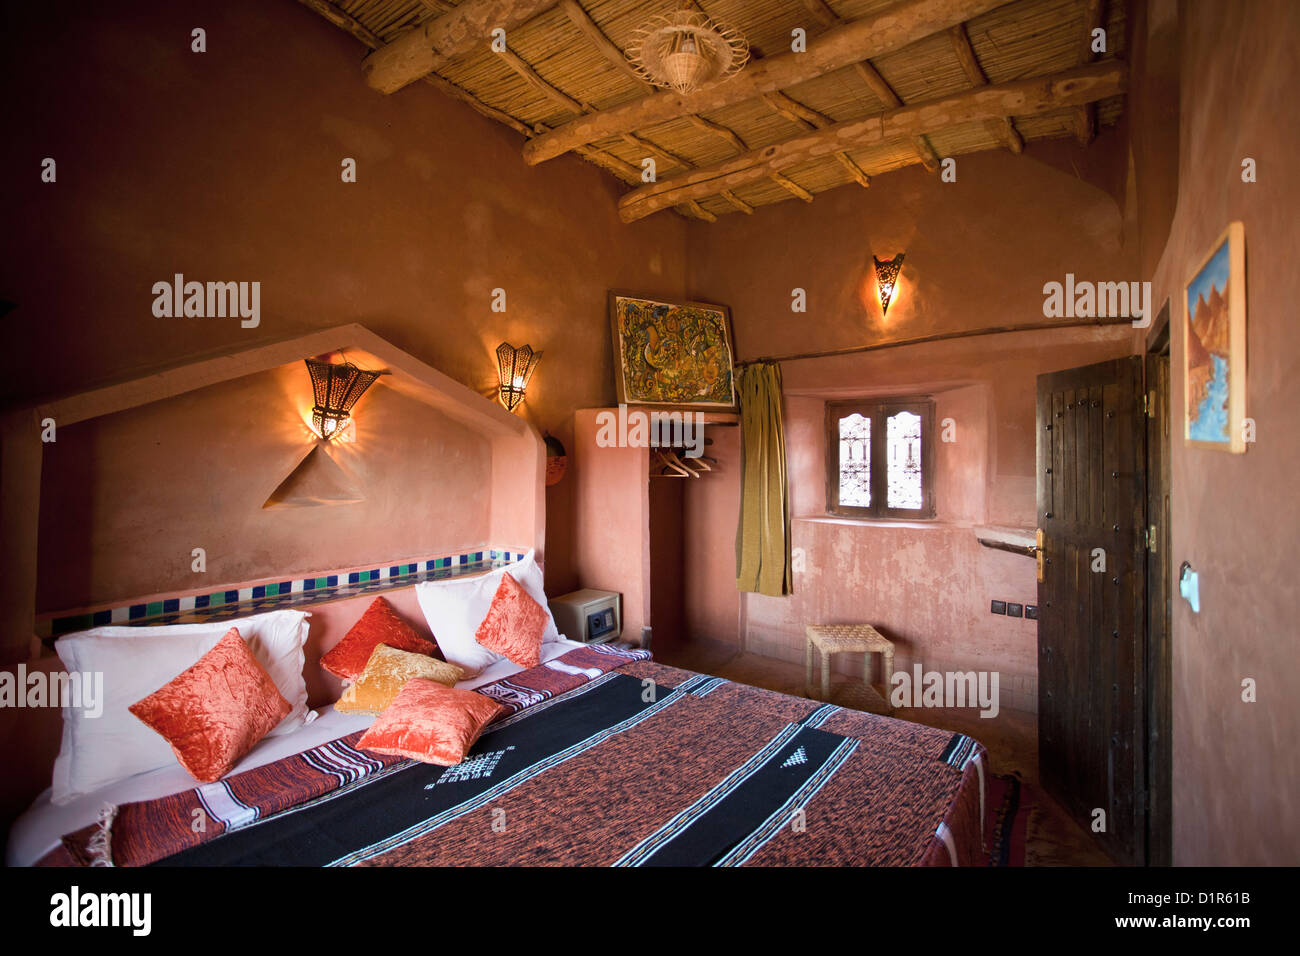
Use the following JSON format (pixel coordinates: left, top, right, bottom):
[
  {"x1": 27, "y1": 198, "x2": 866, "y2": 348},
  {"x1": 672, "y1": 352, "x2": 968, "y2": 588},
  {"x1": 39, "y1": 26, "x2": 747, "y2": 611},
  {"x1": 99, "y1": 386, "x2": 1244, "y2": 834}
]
[{"x1": 356, "y1": 678, "x2": 506, "y2": 767}]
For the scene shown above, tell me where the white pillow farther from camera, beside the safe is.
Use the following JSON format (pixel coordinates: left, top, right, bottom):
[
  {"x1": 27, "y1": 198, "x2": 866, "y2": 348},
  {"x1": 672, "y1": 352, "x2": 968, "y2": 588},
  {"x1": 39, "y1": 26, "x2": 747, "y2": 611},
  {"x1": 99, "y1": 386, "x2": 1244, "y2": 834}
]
[{"x1": 415, "y1": 551, "x2": 560, "y2": 674}]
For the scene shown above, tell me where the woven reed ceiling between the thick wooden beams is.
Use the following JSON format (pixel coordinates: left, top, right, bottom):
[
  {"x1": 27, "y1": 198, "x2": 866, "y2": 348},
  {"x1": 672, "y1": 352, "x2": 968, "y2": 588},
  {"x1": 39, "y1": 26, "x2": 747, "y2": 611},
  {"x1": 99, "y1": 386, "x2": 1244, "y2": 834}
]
[{"x1": 300, "y1": 0, "x2": 1125, "y2": 220}]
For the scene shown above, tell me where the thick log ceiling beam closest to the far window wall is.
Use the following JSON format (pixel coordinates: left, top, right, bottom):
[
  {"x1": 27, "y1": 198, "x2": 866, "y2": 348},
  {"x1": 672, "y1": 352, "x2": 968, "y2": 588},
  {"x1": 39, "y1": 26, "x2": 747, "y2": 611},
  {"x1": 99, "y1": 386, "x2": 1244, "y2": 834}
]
[{"x1": 619, "y1": 60, "x2": 1128, "y2": 222}]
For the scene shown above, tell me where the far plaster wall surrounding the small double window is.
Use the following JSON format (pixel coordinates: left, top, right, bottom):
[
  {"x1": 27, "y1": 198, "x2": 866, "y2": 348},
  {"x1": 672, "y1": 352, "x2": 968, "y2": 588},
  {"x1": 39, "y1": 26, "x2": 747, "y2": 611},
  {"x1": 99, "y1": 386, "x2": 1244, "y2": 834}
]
[{"x1": 686, "y1": 145, "x2": 1139, "y2": 710}]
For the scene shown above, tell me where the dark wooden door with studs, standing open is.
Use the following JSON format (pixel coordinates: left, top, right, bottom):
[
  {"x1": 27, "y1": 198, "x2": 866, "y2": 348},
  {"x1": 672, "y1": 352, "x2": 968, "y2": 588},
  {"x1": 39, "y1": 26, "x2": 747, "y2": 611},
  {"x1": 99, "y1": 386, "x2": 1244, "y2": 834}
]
[{"x1": 1037, "y1": 356, "x2": 1147, "y2": 864}]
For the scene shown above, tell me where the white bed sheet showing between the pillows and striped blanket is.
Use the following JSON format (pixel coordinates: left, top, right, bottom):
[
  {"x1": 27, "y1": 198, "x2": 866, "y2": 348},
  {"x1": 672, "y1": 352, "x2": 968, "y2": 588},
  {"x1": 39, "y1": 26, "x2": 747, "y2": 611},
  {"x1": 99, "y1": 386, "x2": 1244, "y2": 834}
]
[{"x1": 5, "y1": 636, "x2": 584, "y2": 866}]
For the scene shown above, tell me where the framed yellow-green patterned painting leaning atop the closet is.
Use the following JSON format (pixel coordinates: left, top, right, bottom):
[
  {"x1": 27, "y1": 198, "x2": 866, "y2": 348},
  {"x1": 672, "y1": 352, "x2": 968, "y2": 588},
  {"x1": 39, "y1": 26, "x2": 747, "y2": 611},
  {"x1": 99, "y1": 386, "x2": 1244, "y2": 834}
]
[{"x1": 610, "y1": 293, "x2": 736, "y2": 411}]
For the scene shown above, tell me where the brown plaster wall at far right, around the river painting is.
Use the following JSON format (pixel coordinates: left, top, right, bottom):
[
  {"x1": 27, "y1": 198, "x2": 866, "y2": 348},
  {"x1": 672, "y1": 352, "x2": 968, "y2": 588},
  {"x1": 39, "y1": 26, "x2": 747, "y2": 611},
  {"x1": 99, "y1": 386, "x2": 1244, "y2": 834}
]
[{"x1": 1135, "y1": 0, "x2": 1300, "y2": 865}]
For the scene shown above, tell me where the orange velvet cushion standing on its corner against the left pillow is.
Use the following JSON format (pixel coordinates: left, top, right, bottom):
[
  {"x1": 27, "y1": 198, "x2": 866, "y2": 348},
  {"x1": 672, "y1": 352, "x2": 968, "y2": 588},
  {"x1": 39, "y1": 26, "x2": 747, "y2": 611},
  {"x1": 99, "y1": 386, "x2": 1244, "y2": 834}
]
[{"x1": 130, "y1": 627, "x2": 294, "y2": 783}]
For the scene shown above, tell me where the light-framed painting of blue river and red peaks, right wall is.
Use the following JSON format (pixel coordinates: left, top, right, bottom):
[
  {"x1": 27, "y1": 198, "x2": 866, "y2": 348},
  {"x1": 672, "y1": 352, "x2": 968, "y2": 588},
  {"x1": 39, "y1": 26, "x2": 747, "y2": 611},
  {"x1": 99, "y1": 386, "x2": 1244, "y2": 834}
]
[{"x1": 1183, "y1": 222, "x2": 1247, "y2": 454}]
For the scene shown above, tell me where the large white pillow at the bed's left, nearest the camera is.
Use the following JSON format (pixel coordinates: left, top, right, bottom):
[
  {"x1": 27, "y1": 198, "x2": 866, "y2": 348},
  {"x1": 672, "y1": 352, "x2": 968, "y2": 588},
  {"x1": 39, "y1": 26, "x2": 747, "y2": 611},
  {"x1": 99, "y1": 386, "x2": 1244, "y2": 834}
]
[{"x1": 51, "y1": 610, "x2": 316, "y2": 805}]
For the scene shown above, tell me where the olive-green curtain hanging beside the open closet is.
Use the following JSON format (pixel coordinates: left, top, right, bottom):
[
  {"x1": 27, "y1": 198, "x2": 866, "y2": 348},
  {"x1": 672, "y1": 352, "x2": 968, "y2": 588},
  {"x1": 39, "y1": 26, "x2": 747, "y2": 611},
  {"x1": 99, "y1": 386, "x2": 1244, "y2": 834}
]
[{"x1": 736, "y1": 363, "x2": 790, "y2": 597}]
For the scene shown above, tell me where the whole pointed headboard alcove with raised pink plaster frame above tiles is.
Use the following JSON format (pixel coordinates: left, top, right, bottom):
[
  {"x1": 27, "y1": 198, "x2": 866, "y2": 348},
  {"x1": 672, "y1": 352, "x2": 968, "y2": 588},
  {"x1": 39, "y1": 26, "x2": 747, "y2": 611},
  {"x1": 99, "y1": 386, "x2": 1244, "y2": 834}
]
[{"x1": 0, "y1": 325, "x2": 545, "y2": 663}]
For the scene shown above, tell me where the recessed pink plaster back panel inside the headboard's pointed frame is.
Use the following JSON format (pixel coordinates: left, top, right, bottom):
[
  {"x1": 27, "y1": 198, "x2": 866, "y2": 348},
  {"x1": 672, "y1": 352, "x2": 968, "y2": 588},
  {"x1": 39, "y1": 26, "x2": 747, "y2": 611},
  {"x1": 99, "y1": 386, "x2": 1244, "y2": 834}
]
[{"x1": 36, "y1": 362, "x2": 491, "y2": 611}]
